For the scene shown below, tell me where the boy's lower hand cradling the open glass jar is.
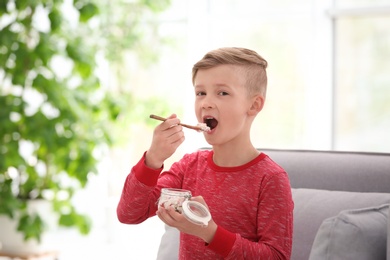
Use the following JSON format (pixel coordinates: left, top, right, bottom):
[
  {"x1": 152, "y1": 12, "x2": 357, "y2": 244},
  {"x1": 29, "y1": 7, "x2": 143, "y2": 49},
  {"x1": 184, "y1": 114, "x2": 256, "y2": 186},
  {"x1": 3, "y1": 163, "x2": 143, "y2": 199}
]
[{"x1": 157, "y1": 196, "x2": 217, "y2": 243}]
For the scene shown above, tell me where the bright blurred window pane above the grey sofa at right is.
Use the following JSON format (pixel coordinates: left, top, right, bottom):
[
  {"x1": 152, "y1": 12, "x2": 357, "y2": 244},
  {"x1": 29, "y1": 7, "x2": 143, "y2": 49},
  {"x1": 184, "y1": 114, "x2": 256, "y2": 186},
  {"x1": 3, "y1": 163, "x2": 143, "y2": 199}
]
[{"x1": 333, "y1": 7, "x2": 390, "y2": 152}]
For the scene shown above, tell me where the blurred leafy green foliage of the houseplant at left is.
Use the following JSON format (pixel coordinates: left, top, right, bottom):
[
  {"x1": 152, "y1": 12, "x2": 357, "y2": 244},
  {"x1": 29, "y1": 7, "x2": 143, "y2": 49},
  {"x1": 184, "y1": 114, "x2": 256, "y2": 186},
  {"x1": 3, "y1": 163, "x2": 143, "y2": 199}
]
[{"x1": 0, "y1": 0, "x2": 172, "y2": 250}]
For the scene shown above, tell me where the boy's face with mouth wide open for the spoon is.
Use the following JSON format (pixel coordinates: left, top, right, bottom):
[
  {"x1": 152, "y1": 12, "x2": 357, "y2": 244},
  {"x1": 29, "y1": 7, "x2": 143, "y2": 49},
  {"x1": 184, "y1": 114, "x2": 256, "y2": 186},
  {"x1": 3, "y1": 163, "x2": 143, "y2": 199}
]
[{"x1": 194, "y1": 65, "x2": 258, "y2": 145}]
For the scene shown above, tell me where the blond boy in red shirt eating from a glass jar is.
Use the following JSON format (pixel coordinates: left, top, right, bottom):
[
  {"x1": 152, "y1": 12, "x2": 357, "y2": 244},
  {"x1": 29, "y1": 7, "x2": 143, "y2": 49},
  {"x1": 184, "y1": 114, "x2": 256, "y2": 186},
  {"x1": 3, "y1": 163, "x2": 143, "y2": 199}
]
[{"x1": 117, "y1": 48, "x2": 293, "y2": 260}]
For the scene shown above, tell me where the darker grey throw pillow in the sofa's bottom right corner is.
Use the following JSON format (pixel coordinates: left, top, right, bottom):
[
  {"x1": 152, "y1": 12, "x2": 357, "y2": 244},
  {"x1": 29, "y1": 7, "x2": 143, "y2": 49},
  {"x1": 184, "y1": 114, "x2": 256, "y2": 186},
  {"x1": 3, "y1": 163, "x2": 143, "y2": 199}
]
[{"x1": 309, "y1": 204, "x2": 389, "y2": 260}]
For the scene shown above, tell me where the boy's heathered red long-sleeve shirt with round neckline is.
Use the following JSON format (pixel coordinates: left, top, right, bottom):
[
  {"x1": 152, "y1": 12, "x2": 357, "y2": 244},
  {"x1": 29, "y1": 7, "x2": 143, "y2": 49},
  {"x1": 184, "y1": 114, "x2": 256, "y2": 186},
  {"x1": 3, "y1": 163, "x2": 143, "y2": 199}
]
[{"x1": 117, "y1": 150, "x2": 294, "y2": 260}]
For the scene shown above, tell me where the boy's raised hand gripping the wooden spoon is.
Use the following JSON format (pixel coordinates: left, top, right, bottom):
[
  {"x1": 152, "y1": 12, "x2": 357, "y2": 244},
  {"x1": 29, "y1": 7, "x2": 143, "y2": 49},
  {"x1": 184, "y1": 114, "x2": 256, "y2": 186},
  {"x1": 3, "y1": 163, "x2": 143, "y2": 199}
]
[{"x1": 145, "y1": 114, "x2": 184, "y2": 169}]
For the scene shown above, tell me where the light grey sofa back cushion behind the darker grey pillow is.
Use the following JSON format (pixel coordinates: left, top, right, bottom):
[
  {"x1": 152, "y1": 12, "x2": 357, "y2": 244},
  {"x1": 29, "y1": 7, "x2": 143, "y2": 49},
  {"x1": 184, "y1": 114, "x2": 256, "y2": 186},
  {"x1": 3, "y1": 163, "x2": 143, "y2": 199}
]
[{"x1": 291, "y1": 189, "x2": 390, "y2": 260}]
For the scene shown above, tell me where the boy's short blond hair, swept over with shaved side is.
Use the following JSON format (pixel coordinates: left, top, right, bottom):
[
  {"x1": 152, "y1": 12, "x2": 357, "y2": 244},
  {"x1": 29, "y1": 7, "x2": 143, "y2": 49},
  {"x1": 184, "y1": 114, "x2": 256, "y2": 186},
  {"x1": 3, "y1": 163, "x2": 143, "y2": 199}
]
[{"x1": 192, "y1": 47, "x2": 268, "y2": 98}]
